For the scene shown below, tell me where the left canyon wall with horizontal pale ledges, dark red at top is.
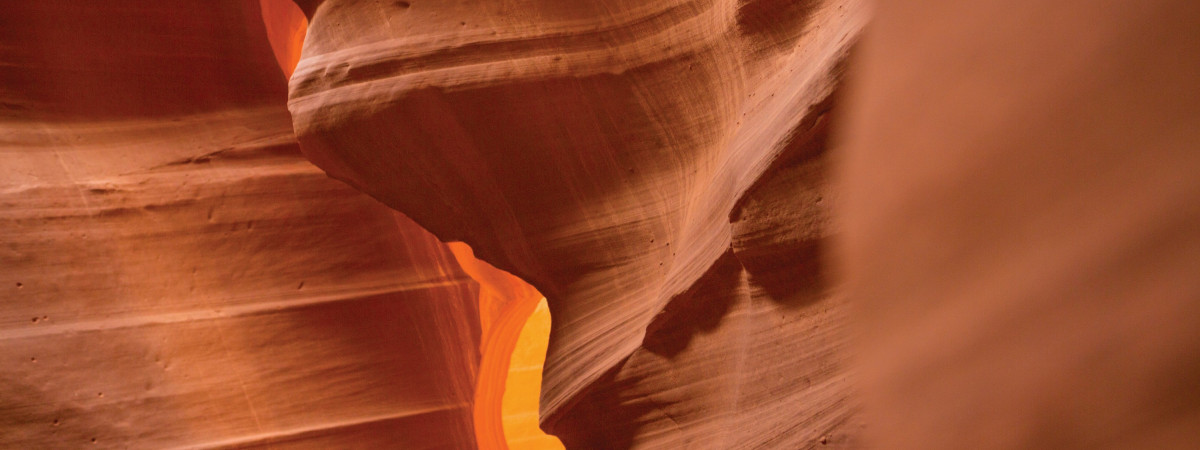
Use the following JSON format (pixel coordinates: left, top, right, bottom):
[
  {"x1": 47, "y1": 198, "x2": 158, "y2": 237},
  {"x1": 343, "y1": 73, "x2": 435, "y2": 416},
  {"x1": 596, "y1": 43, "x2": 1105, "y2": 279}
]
[{"x1": 0, "y1": 0, "x2": 482, "y2": 449}]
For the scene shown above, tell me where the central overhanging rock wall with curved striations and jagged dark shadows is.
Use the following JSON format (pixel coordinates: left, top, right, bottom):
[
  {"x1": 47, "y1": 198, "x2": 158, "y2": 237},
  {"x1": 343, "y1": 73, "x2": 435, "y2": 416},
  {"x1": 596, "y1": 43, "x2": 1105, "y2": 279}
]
[{"x1": 289, "y1": 0, "x2": 864, "y2": 448}]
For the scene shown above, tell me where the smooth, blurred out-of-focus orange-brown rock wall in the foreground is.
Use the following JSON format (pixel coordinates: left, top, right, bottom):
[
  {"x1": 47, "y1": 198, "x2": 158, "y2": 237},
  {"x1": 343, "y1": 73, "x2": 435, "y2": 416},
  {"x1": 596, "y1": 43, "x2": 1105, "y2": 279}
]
[{"x1": 839, "y1": 0, "x2": 1200, "y2": 449}]
